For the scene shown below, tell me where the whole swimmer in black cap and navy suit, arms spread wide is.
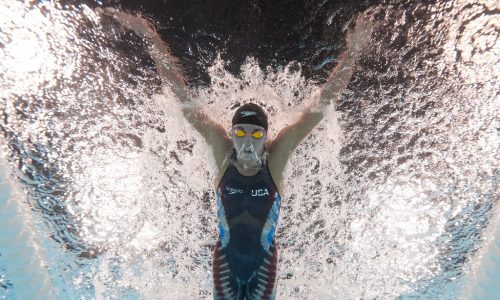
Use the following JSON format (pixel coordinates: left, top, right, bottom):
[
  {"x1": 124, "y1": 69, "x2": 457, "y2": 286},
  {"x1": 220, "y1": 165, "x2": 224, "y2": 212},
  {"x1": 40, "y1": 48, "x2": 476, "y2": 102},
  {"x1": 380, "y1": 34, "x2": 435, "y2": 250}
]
[{"x1": 106, "y1": 10, "x2": 371, "y2": 300}]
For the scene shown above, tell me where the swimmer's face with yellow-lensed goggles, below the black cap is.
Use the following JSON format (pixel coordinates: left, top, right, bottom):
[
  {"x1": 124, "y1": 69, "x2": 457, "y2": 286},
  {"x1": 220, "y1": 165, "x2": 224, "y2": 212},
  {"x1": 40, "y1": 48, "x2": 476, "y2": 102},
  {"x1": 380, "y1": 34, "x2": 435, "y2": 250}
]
[{"x1": 231, "y1": 124, "x2": 267, "y2": 162}]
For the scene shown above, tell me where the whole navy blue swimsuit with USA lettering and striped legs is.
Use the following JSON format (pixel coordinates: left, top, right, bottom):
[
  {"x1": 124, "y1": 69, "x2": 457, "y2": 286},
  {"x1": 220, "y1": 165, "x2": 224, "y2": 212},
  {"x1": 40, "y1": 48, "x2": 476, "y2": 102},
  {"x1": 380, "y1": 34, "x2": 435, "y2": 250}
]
[{"x1": 213, "y1": 157, "x2": 281, "y2": 299}]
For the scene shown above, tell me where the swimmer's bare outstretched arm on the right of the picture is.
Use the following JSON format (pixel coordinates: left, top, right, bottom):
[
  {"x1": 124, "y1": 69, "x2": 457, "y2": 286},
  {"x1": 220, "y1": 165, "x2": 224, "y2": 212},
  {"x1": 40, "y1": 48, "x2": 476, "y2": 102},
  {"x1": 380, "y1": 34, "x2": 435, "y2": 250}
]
[{"x1": 268, "y1": 18, "x2": 371, "y2": 185}]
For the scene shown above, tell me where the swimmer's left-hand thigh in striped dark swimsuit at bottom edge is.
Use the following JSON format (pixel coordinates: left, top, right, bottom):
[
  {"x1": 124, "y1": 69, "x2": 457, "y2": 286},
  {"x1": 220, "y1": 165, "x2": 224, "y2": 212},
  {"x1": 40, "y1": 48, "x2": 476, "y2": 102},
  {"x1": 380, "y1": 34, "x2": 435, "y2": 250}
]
[{"x1": 212, "y1": 241, "x2": 240, "y2": 300}]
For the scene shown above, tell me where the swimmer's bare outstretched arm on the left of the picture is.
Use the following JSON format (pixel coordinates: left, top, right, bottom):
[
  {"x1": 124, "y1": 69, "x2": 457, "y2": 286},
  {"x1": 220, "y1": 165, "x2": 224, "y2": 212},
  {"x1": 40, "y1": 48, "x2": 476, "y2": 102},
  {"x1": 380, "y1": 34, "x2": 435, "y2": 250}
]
[{"x1": 104, "y1": 8, "x2": 231, "y2": 171}]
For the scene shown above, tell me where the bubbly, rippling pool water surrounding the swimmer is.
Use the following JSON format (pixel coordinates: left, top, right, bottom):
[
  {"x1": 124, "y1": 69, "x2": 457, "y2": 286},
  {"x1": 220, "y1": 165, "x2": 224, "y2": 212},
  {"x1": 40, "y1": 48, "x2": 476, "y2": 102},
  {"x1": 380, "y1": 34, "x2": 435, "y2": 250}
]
[{"x1": 0, "y1": 0, "x2": 500, "y2": 299}]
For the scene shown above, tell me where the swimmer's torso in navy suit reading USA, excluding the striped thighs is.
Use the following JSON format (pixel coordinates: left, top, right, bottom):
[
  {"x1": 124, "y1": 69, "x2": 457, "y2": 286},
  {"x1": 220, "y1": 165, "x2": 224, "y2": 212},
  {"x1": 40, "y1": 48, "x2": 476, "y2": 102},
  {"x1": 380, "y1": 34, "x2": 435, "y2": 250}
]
[{"x1": 216, "y1": 158, "x2": 281, "y2": 282}]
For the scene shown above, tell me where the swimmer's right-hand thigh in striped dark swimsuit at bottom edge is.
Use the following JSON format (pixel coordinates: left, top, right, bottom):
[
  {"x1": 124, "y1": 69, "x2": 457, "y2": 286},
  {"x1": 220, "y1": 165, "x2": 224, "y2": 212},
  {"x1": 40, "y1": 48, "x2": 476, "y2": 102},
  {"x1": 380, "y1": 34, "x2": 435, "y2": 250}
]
[{"x1": 247, "y1": 243, "x2": 278, "y2": 300}]
